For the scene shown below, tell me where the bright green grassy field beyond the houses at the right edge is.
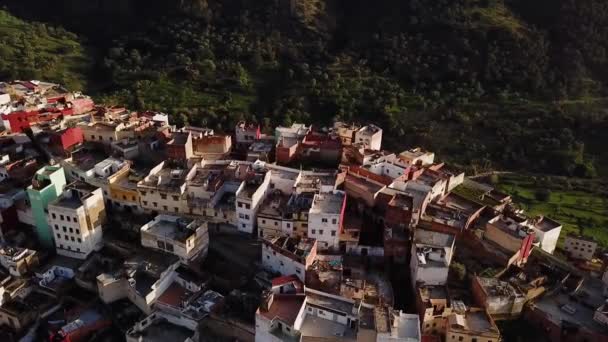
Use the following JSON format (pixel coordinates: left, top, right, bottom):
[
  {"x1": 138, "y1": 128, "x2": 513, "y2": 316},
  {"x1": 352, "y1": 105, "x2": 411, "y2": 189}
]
[{"x1": 497, "y1": 174, "x2": 608, "y2": 248}]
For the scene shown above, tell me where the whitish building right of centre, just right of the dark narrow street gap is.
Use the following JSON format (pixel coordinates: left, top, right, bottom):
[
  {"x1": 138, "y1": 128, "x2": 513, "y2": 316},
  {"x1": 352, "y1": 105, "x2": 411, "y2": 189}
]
[{"x1": 410, "y1": 228, "x2": 456, "y2": 288}]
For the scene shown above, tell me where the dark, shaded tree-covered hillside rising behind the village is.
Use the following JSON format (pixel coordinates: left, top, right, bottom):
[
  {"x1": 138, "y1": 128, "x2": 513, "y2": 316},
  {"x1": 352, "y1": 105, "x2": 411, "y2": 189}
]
[{"x1": 3, "y1": 0, "x2": 608, "y2": 177}]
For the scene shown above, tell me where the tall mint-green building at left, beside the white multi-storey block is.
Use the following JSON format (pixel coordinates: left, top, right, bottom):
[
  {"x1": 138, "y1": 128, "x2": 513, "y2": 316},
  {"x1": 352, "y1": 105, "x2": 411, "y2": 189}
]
[{"x1": 27, "y1": 166, "x2": 66, "y2": 248}]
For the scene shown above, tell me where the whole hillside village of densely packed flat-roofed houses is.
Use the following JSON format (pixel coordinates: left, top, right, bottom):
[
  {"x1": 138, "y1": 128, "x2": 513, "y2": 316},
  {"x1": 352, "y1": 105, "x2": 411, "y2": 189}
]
[{"x1": 0, "y1": 81, "x2": 608, "y2": 342}]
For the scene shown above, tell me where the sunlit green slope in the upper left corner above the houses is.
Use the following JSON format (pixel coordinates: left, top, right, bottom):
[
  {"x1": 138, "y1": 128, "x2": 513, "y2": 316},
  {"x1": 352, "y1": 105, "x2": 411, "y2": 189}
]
[{"x1": 0, "y1": 10, "x2": 92, "y2": 90}]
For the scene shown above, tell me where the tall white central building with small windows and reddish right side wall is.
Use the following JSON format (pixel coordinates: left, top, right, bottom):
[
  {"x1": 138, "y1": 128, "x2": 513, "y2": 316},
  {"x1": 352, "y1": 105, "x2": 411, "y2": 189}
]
[{"x1": 308, "y1": 190, "x2": 346, "y2": 249}]
